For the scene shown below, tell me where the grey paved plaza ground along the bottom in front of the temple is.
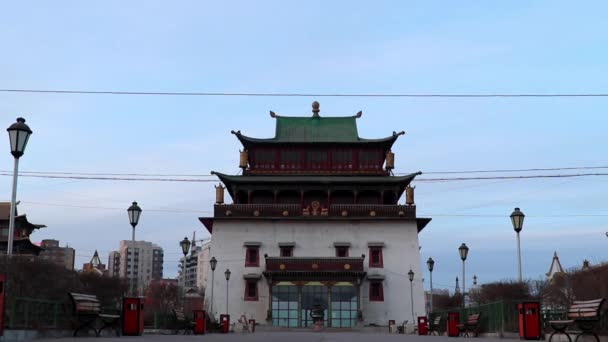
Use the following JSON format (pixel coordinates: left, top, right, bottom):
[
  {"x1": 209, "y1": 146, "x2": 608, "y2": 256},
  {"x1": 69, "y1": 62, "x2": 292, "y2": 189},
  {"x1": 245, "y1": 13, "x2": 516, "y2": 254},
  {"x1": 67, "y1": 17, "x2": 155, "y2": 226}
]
[{"x1": 47, "y1": 331, "x2": 506, "y2": 342}]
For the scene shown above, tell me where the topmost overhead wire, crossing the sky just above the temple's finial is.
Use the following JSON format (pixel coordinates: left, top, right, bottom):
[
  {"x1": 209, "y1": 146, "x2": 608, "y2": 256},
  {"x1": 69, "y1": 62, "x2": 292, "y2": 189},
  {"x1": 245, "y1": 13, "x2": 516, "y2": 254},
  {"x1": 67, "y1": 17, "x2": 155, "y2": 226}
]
[{"x1": 0, "y1": 88, "x2": 608, "y2": 98}]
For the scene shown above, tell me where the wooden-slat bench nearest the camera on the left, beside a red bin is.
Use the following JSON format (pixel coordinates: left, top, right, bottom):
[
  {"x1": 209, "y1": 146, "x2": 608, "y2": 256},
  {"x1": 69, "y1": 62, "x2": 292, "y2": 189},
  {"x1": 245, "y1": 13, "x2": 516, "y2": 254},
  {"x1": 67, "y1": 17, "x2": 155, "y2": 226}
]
[{"x1": 68, "y1": 292, "x2": 120, "y2": 337}]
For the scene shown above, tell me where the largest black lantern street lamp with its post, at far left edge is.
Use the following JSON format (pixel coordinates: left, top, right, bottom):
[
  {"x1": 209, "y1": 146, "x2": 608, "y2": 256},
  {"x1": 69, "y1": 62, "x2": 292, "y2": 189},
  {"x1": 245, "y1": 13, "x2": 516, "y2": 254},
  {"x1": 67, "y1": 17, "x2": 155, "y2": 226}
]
[{"x1": 6, "y1": 118, "x2": 32, "y2": 256}]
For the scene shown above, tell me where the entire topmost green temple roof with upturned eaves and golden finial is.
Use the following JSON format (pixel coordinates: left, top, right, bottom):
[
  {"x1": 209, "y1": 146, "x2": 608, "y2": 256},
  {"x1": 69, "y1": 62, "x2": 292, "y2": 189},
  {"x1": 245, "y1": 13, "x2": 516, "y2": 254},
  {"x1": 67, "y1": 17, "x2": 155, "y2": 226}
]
[{"x1": 232, "y1": 101, "x2": 405, "y2": 147}]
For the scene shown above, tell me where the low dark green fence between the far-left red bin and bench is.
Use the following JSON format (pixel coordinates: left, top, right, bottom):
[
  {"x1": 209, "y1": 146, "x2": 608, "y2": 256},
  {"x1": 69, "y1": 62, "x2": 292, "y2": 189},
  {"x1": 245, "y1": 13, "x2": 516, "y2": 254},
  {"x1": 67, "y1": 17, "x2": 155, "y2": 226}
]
[{"x1": 6, "y1": 297, "x2": 68, "y2": 329}]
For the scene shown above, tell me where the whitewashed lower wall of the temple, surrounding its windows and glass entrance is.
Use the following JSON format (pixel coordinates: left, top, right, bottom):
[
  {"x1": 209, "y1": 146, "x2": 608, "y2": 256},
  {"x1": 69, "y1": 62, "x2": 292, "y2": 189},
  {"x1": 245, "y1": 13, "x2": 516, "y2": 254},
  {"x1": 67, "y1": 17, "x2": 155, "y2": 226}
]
[{"x1": 204, "y1": 219, "x2": 425, "y2": 325}]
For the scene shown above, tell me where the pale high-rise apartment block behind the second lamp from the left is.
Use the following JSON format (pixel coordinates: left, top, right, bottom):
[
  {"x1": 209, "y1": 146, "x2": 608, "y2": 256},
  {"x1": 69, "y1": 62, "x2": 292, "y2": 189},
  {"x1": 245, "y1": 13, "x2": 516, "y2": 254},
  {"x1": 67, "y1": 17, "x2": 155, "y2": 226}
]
[{"x1": 118, "y1": 240, "x2": 164, "y2": 293}]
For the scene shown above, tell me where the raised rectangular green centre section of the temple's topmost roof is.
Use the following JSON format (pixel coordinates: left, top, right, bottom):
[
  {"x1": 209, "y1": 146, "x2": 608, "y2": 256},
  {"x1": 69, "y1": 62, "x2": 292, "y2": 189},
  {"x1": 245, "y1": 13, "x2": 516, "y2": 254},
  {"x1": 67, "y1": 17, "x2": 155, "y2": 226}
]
[{"x1": 274, "y1": 116, "x2": 359, "y2": 143}]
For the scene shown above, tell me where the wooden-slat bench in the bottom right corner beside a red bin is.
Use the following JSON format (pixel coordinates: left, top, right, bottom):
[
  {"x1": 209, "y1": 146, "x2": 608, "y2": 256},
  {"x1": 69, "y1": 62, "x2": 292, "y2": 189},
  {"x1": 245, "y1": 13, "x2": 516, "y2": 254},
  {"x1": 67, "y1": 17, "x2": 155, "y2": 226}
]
[{"x1": 549, "y1": 298, "x2": 605, "y2": 342}]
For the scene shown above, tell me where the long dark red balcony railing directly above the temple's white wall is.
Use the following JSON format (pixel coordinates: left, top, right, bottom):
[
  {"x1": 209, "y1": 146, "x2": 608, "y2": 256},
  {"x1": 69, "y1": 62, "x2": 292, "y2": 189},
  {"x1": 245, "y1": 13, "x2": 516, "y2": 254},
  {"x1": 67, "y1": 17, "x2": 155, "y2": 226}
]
[{"x1": 214, "y1": 204, "x2": 416, "y2": 219}]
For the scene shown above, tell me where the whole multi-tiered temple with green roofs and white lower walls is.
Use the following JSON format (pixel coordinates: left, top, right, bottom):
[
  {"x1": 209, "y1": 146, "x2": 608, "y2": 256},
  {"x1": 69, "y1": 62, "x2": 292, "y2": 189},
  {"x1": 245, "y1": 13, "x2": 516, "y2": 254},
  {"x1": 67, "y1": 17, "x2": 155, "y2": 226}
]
[{"x1": 200, "y1": 101, "x2": 431, "y2": 328}]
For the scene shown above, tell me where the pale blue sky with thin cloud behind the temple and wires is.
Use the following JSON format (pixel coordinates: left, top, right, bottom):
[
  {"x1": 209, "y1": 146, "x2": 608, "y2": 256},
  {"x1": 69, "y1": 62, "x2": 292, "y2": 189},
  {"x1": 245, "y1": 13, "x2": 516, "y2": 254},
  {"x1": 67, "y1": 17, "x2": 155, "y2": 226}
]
[{"x1": 0, "y1": 1, "x2": 608, "y2": 287}]
